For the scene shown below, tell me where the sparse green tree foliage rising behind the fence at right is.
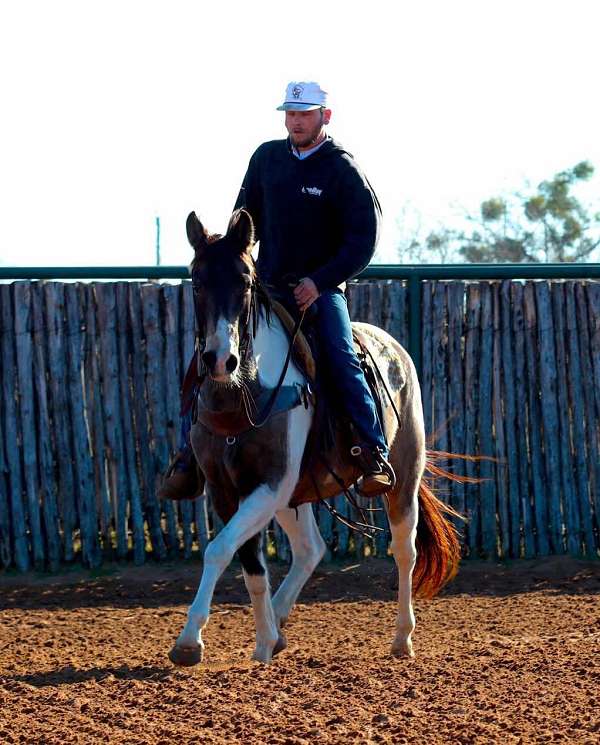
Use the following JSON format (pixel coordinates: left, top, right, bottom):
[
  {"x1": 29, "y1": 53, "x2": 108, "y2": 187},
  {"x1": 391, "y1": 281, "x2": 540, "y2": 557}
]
[{"x1": 399, "y1": 161, "x2": 600, "y2": 263}]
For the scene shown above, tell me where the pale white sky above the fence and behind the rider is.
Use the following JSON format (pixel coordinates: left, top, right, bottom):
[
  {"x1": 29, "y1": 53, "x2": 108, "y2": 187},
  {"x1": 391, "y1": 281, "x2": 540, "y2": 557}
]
[{"x1": 0, "y1": 0, "x2": 600, "y2": 266}]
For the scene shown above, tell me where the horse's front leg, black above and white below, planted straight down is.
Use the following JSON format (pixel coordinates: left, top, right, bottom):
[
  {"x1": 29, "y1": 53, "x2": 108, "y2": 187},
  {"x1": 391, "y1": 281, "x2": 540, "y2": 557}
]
[{"x1": 238, "y1": 533, "x2": 286, "y2": 662}]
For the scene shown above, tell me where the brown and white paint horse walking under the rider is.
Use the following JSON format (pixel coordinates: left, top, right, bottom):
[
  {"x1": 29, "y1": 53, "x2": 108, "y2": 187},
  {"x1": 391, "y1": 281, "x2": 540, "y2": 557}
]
[{"x1": 169, "y1": 210, "x2": 459, "y2": 666}]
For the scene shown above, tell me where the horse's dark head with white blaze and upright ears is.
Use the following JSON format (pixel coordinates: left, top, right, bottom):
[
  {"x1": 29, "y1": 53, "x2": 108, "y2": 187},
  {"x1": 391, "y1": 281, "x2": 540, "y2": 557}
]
[{"x1": 186, "y1": 210, "x2": 256, "y2": 383}]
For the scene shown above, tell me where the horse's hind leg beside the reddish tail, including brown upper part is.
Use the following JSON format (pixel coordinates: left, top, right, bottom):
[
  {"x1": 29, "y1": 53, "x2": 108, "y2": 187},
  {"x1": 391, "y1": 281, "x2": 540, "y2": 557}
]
[{"x1": 386, "y1": 481, "x2": 419, "y2": 657}]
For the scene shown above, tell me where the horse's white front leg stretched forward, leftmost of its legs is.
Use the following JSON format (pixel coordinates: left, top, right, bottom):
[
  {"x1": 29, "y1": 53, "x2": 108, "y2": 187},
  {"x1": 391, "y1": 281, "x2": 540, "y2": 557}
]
[{"x1": 169, "y1": 484, "x2": 282, "y2": 667}]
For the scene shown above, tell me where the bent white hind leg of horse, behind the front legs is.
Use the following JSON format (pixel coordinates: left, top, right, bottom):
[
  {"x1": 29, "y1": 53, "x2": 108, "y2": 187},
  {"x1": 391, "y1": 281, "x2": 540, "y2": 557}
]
[{"x1": 273, "y1": 504, "x2": 326, "y2": 629}]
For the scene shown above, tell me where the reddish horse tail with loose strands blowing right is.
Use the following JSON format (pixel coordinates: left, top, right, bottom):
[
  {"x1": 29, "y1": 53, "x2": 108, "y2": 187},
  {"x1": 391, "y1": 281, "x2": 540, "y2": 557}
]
[{"x1": 413, "y1": 450, "x2": 481, "y2": 598}]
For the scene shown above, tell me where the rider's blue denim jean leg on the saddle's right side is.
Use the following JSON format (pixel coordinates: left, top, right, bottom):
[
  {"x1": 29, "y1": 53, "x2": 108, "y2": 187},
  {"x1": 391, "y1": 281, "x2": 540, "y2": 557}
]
[{"x1": 315, "y1": 290, "x2": 388, "y2": 458}]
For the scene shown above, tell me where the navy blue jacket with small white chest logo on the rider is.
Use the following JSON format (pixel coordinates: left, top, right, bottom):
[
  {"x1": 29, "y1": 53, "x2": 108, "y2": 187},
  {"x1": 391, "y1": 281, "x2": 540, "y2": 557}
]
[{"x1": 236, "y1": 138, "x2": 381, "y2": 292}]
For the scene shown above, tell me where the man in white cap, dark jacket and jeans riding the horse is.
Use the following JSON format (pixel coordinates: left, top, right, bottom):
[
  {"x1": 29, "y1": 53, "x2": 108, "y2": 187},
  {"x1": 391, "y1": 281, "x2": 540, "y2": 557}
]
[{"x1": 159, "y1": 82, "x2": 394, "y2": 499}]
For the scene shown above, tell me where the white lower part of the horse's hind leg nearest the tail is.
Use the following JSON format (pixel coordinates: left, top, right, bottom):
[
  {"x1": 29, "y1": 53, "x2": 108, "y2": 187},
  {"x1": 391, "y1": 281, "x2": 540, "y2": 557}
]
[{"x1": 390, "y1": 503, "x2": 418, "y2": 657}]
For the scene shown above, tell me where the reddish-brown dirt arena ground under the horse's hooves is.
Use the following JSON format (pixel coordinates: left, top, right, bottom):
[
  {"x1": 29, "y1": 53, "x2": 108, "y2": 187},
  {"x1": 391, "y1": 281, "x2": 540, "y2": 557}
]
[{"x1": 0, "y1": 558, "x2": 600, "y2": 745}]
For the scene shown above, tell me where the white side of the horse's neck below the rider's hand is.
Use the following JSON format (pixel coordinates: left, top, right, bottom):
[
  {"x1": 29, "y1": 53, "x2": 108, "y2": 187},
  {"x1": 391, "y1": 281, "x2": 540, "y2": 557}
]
[{"x1": 252, "y1": 310, "x2": 304, "y2": 388}]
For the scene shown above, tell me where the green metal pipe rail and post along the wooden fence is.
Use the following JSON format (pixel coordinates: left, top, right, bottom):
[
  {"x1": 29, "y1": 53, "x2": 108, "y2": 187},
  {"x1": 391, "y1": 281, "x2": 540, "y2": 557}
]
[{"x1": 0, "y1": 264, "x2": 600, "y2": 377}]
